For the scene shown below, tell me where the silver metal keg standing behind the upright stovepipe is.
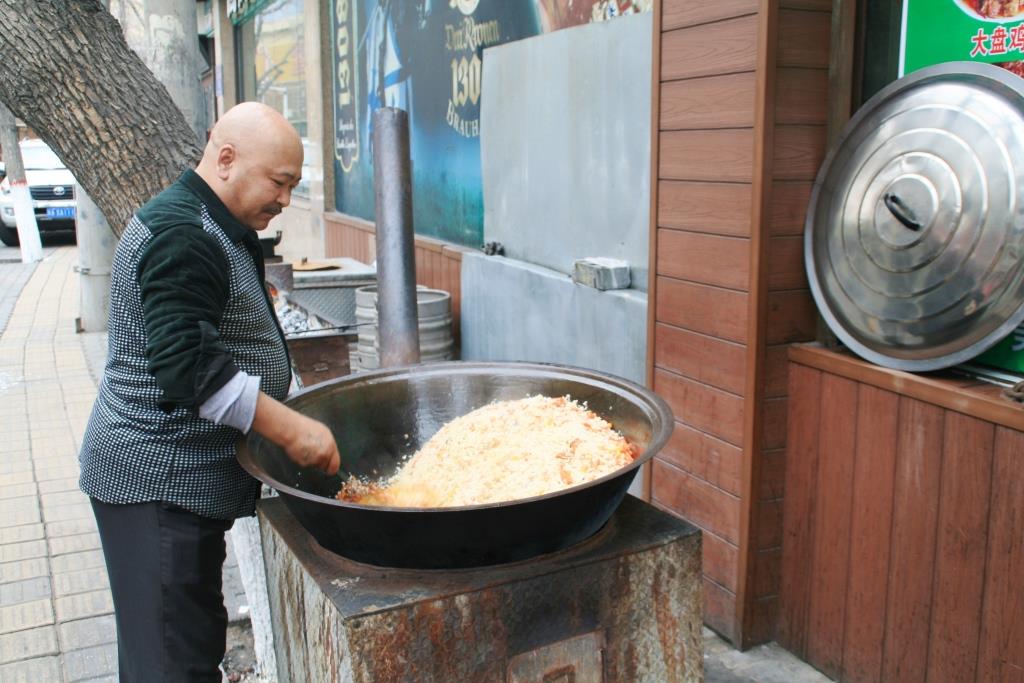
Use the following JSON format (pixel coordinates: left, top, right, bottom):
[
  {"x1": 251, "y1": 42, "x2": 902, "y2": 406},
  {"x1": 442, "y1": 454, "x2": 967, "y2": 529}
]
[{"x1": 352, "y1": 285, "x2": 455, "y2": 370}]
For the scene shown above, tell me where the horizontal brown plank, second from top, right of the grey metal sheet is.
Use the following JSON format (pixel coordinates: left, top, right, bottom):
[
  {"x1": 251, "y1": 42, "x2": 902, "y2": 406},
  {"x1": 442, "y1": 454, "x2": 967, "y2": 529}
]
[{"x1": 662, "y1": 15, "x2": 758, "y2": 81}]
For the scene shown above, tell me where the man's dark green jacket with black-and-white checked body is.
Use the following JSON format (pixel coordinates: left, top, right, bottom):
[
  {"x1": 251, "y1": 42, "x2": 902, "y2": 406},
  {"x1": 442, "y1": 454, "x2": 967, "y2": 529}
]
[{"x1": 80, "y1": 171, "x2": 291, "y2": 519}]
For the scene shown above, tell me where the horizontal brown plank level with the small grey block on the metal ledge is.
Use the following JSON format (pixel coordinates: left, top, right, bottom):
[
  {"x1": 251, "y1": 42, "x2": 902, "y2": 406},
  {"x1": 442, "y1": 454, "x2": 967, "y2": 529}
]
[{"x1": 656, "y1": 229, "x2": 751, "y2": 291}]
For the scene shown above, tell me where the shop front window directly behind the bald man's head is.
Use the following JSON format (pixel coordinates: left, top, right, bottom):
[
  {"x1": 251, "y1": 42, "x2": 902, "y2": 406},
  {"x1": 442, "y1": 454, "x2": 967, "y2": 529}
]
[{"x1": 236, "y1": 0, "x2": 310, "y2": 196}]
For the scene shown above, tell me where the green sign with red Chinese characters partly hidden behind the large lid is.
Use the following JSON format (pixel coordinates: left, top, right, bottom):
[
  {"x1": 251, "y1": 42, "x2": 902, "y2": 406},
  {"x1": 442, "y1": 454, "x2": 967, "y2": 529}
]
[{"x1": 899, "y1": 0, "x2": 1024, "y2": 372}]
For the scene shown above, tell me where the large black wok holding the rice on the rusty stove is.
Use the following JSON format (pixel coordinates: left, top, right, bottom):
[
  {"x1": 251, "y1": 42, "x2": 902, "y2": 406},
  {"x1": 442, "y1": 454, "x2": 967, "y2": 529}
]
[{"x1": 238, "y1": 362, "x2": 673, "y2": 568}]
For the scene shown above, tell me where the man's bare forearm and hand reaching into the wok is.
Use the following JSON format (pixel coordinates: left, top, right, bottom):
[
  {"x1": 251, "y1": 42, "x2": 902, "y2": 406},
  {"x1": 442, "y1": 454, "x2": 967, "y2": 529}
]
[{"x1": 252, "y1": 391, "x2": 341, "y2": 474}]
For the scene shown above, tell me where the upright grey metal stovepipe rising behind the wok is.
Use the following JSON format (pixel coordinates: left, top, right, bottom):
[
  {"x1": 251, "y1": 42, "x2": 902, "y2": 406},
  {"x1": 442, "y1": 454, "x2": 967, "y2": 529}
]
[{"x1": 373, "y1": 106, "x2": 420, "y2": 367}]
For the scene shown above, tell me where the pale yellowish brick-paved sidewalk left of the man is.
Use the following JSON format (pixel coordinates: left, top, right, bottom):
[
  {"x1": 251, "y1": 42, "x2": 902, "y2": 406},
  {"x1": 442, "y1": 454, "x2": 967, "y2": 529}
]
[{"x1": 0, "y1": 248, "x2": 117, "y2": 683}]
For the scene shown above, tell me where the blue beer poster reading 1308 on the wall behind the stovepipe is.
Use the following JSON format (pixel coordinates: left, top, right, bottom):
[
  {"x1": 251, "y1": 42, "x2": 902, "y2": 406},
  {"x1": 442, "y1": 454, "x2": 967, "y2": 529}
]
[{"x1": 330, "y1": 0, "x2": 652, "y2": 247}]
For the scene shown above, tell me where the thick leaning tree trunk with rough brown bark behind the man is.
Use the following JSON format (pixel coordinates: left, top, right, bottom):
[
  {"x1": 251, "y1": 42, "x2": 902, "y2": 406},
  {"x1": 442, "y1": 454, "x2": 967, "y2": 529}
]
[{"x1": 0, "y1": 0, "x2": 202, "y2": 234}]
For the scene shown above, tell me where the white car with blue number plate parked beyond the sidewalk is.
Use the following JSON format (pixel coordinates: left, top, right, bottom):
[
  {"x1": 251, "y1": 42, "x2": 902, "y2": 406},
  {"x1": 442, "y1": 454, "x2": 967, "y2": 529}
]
[{"x1": 0, "y1": 140, "x2": 77, "y2": 247}]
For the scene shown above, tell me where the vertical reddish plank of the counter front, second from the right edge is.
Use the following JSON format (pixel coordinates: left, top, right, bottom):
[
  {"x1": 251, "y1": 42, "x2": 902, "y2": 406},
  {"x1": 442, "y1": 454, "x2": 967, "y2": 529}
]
[{"x1": 928, "y1": 413, "x2": 995, "y2": 681}]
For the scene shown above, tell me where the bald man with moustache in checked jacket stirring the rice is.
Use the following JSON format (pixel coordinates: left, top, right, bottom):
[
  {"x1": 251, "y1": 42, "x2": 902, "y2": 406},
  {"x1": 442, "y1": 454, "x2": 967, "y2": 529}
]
[{"x1": 80, "y1": 102, "x2": 339, "y2": 681}]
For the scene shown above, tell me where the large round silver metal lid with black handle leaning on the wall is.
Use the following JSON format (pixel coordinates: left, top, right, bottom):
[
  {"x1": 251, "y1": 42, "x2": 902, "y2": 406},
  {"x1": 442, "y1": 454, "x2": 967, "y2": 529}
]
[{"x1": 804, "y1": 62, "x2": 1024, "y2": 371}]
